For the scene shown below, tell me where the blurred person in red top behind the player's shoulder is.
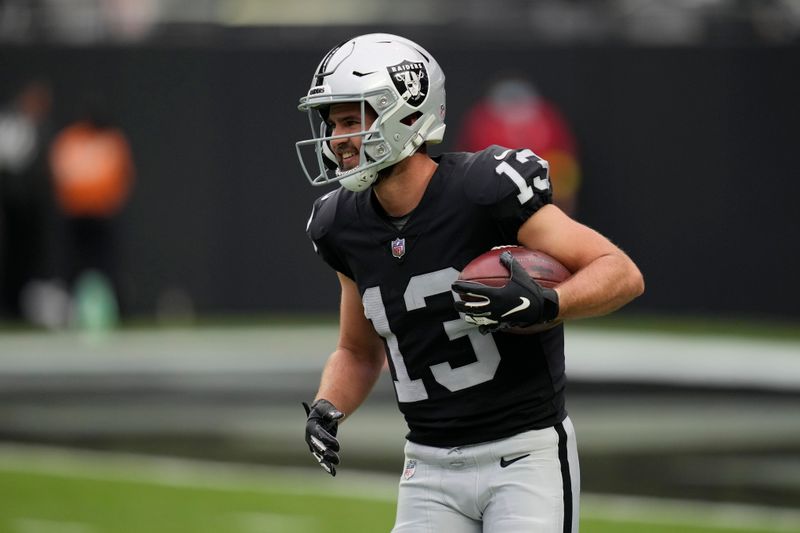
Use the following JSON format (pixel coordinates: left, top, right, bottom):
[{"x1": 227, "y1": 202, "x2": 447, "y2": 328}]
[{"x1": 456, "y1": 77, "x2": 581, "y2": 216}]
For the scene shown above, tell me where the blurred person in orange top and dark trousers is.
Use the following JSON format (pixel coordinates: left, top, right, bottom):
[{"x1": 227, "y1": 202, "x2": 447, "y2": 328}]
[{"x1": 50, "y1": 93, "x2": 134, "y2": 329}]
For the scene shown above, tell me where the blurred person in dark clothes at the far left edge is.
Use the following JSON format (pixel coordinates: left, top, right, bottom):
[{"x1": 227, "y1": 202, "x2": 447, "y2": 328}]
[{"x1": 0, "y1": 80, "x2": 52, "y2": 320}]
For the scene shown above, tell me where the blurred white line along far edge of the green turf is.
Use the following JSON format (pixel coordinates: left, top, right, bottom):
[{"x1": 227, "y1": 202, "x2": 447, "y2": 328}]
[{"x1": 0, "y1": 444, "x2": 800, "y2": 532}]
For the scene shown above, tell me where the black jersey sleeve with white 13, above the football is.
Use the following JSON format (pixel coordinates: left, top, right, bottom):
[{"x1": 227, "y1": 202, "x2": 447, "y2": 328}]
[{"x1": 465, "y1": 146, "x2": 553, "y2": 239}]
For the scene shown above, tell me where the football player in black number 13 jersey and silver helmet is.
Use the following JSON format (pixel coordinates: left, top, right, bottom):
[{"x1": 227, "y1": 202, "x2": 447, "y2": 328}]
[{"x1": 297, "y1": 34, "x2": 644, "y2": 533}]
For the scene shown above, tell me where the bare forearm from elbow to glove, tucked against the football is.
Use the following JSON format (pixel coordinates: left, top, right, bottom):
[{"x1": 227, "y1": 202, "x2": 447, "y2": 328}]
[{"x1": 556, "y1": 252, "x2": 644, "y2": 319}]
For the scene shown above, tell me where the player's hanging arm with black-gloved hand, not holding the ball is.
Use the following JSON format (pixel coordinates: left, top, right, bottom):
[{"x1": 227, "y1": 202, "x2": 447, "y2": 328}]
[{"x1": 303, "y1": 273, "x2": 385, "y2": 476}]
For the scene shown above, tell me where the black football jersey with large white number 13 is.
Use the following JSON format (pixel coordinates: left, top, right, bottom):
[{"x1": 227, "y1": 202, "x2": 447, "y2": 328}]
[{"x1": 308, "y1": 146, "x2": 566, "y2": 447}]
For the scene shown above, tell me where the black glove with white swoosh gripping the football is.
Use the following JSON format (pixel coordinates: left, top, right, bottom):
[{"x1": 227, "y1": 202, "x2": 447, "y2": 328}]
[{"x1": 453, "y1": 252, "x2": 558, "y2": 334}]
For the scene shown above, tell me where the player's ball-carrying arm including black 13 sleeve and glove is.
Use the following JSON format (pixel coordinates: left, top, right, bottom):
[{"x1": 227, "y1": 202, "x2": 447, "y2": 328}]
[{"x1": 453, "y1": 147, "x2": 644, "y2": 332}]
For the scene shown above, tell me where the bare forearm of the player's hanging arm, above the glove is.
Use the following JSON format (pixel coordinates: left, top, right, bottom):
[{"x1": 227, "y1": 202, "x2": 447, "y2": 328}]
[{"x1": 317, "y1": 349, "x2": 383, "y2": 417}]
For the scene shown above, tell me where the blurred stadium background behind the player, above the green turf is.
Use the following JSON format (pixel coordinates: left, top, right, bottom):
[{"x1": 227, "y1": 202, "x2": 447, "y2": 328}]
[{"x1": 0, "y1": 0, "x2": 800, "y2": 528}]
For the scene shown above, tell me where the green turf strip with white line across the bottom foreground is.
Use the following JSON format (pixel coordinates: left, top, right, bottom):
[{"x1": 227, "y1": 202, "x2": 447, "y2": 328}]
[{"x1": 0, "y1": 447, "x2": 800, "y2": 533}]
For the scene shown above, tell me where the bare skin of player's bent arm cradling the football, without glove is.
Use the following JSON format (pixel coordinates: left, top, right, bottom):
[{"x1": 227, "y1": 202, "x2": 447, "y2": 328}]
[{"x1": 517, "y1": 204, "x2": 644, "y2": 319}]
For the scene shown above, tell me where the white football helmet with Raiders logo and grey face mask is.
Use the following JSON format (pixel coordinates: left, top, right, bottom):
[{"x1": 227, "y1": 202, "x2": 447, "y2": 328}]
[{"x1": 296, "y1": 33, "x2": 445, "y2": 191}]
